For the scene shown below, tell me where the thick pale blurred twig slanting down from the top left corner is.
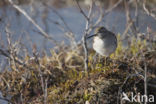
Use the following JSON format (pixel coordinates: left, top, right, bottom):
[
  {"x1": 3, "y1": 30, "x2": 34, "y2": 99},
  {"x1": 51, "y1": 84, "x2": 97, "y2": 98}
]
[{"x1": 8, "y1": 0, "x2": 58, "y2": 45}]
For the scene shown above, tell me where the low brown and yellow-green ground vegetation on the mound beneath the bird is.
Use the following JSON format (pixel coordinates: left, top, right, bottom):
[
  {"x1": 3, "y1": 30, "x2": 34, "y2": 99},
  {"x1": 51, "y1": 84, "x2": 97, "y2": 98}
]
[{"x1": 0, "y1": 37, "x2": 156, "y2": 104}]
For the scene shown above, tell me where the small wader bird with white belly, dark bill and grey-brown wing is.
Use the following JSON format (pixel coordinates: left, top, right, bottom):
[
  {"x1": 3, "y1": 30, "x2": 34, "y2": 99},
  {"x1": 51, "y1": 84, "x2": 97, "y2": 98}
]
[{"x1": 87, "y1": 26, "x2": 117, "y2": 63}]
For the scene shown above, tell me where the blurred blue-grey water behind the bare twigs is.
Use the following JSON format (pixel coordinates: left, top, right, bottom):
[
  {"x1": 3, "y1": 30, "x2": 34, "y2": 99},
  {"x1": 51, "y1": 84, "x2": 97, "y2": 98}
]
[{"x1": 0, "y1": 3, "x2": 156, "y2": 50}]
